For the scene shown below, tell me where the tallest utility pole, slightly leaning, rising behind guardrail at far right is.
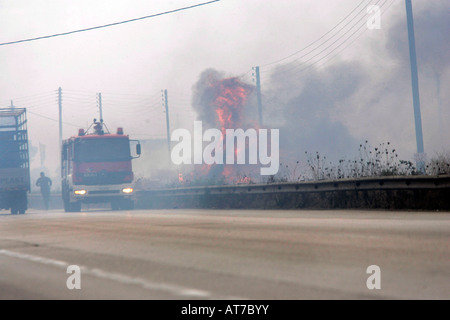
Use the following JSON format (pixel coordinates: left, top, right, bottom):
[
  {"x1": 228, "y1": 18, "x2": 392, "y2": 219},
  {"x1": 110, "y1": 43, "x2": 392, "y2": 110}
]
[{"x1": 405, "y1": 0, "x2": 425, "y2": 173}]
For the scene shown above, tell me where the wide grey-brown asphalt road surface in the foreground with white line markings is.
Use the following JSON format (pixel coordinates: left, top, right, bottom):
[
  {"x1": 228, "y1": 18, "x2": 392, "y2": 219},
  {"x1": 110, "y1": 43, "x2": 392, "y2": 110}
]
[{"x1": 0, "y1": 209, "x2": 450, "y2": 300}]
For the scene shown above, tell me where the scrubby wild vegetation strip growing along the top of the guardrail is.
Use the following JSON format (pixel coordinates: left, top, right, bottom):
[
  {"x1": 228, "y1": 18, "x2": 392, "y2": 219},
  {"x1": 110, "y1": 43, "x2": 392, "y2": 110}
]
[{"x1": 138, "y1": 141, "x2": 450, "y2": 189}]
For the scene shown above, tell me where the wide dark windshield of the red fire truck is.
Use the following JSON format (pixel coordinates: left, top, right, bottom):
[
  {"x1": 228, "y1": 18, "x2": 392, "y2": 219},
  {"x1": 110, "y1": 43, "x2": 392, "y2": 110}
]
[{"x1": 75, "y1": 138, "x2": 131, "y2": 162}]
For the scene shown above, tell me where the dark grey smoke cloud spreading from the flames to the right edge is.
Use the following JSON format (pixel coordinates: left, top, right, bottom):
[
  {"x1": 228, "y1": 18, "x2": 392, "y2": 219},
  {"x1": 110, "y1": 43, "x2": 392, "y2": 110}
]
[{"x1": 188, "y1": 1, "x2": 450, "y2": 182}]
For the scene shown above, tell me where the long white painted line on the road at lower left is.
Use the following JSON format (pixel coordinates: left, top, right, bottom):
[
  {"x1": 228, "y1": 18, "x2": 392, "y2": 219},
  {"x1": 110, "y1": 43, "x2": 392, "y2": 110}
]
[{"x1": 0, "y1": 249, "x2": 237, "y2": 299}]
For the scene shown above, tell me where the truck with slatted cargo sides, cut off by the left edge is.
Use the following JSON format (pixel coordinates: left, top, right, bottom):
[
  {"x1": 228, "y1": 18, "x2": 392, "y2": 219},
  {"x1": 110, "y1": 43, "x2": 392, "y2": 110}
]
[{"x1": 0, "y1": 107, "x2": 31, "y2": 214}]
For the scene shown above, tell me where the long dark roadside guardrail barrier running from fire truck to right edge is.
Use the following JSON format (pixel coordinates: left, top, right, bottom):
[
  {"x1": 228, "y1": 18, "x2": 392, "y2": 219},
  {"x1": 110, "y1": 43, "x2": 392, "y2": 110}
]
[{"x1": 138, "y1": 175, "x2": 450, "y2": 210}]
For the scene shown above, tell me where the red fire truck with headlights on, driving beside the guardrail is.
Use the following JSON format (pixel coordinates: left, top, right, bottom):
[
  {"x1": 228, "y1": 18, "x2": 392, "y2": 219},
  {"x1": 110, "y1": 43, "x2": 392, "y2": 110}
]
[{"x1": 61, "y1": 119, "x2": 141, "y2": 212}]
